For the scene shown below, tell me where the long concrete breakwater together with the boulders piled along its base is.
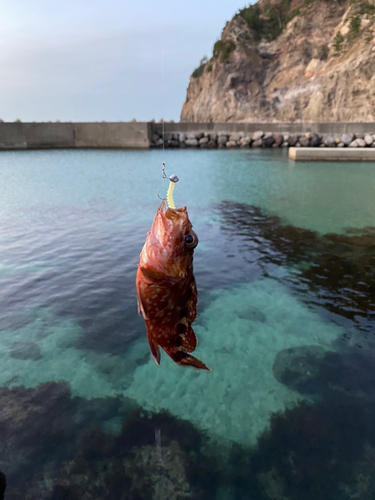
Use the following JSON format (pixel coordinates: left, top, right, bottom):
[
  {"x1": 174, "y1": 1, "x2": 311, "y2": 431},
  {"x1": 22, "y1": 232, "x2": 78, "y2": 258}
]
[{"x1": 0, "y1": 121, "x2": 375, "y2": 150}]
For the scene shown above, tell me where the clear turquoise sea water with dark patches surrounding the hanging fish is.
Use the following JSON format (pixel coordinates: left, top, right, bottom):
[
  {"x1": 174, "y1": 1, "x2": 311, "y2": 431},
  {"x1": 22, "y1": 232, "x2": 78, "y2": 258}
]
[{"x1": 0, "y1": 150, "x2": 375, "y2": 500}]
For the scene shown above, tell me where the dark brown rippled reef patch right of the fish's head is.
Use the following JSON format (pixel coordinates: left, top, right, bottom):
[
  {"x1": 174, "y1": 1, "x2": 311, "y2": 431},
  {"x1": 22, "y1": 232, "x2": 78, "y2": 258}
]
[{"x1": 217, "y1": 201, "x2": 375, "y2": 332}]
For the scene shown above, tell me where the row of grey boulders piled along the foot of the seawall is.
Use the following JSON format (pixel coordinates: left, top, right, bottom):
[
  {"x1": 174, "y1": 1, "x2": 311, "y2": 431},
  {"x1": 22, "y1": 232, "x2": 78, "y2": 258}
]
[{"x1": 150, "y1": 130, "x2": 375, "y2": 149}]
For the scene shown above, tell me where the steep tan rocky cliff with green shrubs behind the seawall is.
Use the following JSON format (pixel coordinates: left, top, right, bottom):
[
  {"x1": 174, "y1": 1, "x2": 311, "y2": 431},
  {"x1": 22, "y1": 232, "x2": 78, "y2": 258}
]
[{"x1": 181, "y1": 0, "x2": 375, "y2": 122}]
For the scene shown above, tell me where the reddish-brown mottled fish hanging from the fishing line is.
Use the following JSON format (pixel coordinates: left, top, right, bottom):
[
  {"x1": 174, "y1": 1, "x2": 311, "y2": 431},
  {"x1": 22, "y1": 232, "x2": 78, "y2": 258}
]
[{"x1": 136, "y1": 199, "x2": 211, "y2": 371}]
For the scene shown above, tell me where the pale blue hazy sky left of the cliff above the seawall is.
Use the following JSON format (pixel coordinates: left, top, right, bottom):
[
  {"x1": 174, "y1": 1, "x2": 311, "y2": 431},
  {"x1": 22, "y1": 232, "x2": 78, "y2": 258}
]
[{"x1": 0, "y1": 0, "x2": 248, "y2": 122}]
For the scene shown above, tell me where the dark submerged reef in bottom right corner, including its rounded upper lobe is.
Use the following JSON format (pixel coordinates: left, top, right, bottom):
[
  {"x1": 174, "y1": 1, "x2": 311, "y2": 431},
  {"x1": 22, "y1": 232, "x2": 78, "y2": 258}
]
[{"x1": 228, "y1": 346, "x2": 375, "y2": 500}]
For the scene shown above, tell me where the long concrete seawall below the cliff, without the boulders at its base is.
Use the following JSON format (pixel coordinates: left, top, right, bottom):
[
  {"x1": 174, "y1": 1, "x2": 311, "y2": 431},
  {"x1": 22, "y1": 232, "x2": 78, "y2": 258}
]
[{"x1": 0, "y1": 122, "x2": 375, "y2": 150}]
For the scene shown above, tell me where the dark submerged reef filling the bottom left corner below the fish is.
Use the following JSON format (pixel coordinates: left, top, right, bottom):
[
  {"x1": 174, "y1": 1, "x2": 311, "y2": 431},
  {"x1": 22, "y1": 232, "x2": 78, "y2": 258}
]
[{"x1": 0, "y1": 383, "x2": 219, "y2": 500}]
